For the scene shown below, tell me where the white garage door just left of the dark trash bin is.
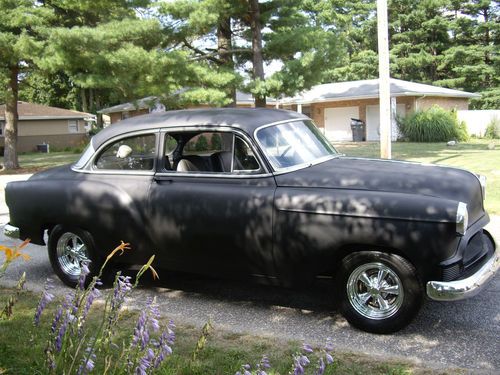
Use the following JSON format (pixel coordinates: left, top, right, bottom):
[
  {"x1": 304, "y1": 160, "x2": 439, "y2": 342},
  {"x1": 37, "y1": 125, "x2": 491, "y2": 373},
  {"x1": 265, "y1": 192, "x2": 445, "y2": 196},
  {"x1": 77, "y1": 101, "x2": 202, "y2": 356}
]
[{"x1": 325, "y1": 107, "x2": 359, "y2": 141}]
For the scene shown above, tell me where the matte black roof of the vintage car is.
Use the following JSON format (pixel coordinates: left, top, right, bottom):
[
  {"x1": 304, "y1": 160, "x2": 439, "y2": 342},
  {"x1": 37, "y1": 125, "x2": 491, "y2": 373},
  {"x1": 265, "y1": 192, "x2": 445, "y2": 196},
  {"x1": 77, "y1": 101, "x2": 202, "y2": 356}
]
[{"x1": 92, "y1": 108, "x2": 308, "y2": 149}]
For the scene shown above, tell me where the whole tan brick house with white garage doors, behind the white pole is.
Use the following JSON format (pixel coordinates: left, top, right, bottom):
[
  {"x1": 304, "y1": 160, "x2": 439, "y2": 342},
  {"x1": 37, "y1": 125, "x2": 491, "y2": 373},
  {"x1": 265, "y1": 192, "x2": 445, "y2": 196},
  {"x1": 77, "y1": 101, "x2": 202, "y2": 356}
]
[{"x1": 280, "y1": 78, "x2": 479, "y2": 141}]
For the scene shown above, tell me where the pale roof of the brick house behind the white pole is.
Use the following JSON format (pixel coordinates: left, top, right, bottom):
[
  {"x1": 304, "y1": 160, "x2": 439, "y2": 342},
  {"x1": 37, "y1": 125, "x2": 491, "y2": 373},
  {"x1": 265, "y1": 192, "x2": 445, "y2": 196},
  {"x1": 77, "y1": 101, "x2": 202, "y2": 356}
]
[{"x1": 281, "y1": 78, "x2": 480, "y2": 104}]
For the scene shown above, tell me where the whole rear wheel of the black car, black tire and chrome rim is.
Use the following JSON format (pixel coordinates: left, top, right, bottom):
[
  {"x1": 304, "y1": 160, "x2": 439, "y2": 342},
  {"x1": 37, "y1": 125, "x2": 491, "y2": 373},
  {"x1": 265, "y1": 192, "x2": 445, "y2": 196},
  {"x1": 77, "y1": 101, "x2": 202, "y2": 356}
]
[{"x1": 47, "y1": 225, "x2": 101, "y2": 287}]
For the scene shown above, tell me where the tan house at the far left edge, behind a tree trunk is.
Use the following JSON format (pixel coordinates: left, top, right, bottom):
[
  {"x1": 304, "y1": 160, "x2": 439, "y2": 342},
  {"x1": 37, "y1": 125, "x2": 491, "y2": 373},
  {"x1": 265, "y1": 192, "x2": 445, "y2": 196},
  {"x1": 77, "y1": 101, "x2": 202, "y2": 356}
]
[{"x1": 0, "y1": 101, "x2": 93, "y2": 154}]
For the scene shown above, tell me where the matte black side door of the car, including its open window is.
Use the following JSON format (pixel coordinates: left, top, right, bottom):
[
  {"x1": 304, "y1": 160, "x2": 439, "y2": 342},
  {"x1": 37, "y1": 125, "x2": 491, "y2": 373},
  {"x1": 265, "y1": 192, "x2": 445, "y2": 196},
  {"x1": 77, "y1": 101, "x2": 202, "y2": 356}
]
[{"x1": 150, "y1": 129, "x2": 276, "y2": 277}]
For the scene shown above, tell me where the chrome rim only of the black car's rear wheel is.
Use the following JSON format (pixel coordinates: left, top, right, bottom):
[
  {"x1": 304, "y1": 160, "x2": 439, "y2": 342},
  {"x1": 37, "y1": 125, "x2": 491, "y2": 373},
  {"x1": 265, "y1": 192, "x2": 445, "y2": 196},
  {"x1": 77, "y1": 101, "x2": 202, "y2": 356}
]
[{"x1": 56, "y1": 232, "x2": 90, "y2": 276}]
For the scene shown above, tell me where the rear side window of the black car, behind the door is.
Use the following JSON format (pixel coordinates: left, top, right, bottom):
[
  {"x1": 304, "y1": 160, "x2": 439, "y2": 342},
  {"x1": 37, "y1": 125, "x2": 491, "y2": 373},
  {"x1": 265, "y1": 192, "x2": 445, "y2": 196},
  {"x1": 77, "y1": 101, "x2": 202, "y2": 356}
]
[{"x1": 95, "y1": 134, "x2": 156, "y2": 171}]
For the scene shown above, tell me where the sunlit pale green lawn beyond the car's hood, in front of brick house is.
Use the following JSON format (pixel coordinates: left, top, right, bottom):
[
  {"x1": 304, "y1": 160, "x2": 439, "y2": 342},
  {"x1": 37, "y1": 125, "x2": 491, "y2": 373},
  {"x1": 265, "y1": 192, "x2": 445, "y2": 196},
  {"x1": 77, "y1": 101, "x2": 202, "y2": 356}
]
[{"x1": 334, "y1": 139, "x2": 500, "y2": 215}]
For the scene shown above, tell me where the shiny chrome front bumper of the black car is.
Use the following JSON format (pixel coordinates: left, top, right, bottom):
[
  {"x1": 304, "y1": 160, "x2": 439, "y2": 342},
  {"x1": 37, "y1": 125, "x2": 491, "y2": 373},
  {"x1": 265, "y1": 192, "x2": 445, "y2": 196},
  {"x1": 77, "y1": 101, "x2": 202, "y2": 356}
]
[{"x1": 427, "y1": 248, "x2": 500, "y2": 301}]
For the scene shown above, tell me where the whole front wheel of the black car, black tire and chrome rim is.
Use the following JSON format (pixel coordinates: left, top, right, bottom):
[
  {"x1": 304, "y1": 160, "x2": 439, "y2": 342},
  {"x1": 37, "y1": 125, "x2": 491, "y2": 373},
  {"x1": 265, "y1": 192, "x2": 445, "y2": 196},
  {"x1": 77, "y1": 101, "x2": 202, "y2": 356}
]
[{"x1": 337, "y1": 251, "x2": 423, "y2": 333}]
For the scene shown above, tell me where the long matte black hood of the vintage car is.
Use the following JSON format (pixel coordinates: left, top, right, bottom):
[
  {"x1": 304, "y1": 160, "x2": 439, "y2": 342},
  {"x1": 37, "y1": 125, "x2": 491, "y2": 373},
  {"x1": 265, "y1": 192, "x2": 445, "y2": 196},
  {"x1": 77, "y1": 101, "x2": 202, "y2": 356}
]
[{"x1": 276, "y1": 157, "x2": 484, "y2": 222}]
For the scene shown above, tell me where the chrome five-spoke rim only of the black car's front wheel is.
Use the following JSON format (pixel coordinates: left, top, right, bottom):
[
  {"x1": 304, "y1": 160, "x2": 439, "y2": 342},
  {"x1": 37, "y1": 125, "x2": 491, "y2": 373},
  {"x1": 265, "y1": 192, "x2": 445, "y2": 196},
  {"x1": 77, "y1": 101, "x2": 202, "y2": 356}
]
[{"x1": 347, "y1": 262, "x2": 404, "y2": 320}]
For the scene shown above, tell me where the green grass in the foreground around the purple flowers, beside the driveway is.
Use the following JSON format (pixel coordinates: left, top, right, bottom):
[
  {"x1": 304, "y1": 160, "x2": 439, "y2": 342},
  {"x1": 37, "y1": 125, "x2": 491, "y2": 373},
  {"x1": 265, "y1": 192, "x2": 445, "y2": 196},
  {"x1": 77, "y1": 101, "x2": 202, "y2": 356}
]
[{"x1": 0, "y1": 290, "x2": 456, "y2": 375}]
